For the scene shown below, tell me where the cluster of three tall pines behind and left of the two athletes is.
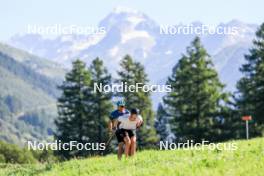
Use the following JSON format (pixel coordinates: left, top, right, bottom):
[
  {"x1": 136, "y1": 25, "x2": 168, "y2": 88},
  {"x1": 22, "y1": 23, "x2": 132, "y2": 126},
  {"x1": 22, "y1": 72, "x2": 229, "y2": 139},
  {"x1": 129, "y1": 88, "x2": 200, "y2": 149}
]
[{"x1": 55, "y1": 55, "x2": 157, "y2": 158}]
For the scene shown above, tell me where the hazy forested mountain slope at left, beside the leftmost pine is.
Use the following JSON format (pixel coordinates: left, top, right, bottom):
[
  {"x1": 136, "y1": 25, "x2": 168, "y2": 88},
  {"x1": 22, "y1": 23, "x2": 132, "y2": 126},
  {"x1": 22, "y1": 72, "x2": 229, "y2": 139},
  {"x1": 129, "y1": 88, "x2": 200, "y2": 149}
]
[{"x1": 0, "y1": 43, "x2": 65, "y2": 145}]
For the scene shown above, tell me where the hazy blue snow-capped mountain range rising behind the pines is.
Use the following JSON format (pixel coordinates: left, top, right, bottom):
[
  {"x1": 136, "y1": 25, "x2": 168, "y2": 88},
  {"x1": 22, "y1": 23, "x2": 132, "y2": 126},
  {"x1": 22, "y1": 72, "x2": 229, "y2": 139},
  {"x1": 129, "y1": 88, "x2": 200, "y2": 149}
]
[{"x1": 6, "y1": 7, "x2": 258, "y2": 104}]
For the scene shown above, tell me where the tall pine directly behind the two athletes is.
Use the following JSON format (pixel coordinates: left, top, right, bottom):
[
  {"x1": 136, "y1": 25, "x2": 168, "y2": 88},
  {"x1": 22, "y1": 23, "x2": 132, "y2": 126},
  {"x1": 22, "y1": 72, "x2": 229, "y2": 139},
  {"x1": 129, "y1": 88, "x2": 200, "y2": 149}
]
[{"x1": 118, "y1": 55, "x2": 157, "y2": 147}]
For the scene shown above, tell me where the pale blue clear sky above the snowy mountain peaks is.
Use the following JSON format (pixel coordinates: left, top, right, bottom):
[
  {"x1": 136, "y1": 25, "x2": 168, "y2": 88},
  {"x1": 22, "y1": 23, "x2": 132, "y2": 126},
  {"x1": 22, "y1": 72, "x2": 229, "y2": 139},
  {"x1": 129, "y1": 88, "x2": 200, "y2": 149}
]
[{"x1": 0, "y1": 0, "x2": 264, "y2": 41}]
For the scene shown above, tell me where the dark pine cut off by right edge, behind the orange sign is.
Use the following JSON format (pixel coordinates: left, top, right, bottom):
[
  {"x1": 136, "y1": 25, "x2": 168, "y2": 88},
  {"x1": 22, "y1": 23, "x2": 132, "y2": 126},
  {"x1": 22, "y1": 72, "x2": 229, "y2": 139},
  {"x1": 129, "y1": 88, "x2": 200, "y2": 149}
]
[{"x1": 236, "y1": 23, "x2": 264, "y2": 136}]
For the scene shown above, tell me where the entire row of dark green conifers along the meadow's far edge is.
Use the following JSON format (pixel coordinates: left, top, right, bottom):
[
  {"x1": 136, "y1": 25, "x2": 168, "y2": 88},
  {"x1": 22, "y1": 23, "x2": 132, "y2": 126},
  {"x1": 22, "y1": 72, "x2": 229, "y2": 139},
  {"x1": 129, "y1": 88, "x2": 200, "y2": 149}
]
[{"x1": 55, "y1": 24, "x2": 264, "y2": 158}]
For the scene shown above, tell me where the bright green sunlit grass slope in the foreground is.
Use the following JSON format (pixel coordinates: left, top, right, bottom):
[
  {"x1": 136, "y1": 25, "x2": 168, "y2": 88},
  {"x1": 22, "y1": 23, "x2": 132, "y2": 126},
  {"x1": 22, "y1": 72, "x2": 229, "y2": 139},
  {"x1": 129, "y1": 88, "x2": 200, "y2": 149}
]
[{"x1": 0, "y1": 138, "x2": 264, "y2": 176}]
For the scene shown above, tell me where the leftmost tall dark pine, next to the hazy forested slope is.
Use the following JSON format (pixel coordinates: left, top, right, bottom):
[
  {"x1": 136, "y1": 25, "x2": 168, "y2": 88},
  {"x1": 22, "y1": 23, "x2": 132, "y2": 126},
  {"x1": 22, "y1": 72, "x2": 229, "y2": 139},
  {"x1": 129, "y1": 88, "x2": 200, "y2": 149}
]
[{"x1": 55, "y1": 60, "x2": 91, "y2": 158}]
